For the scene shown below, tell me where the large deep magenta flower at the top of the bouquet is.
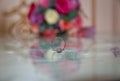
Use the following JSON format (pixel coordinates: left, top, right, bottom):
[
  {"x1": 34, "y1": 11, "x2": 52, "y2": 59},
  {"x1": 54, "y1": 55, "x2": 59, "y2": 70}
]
[{"x1": 55, "y1": 0, "x2": 70, "y2": 14}]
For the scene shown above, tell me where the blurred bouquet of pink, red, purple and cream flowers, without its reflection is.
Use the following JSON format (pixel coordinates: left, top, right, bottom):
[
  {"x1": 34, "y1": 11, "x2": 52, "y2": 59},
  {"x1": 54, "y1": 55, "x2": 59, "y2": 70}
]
[{"x1": 28, "y1": 0, "x2": 82, "y2": 37}]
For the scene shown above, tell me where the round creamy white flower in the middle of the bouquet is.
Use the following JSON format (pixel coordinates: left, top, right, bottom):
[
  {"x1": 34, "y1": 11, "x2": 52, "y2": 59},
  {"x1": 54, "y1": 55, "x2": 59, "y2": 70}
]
[{"x1": 45, "y1": 9, "x2": 59, "y2": 25}]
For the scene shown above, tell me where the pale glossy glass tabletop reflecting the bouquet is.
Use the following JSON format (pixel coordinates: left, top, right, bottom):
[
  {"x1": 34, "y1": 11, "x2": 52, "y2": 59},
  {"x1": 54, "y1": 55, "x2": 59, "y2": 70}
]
[{"x1": 0, "y1": 36, "x2": 120, "y2": 81}]
